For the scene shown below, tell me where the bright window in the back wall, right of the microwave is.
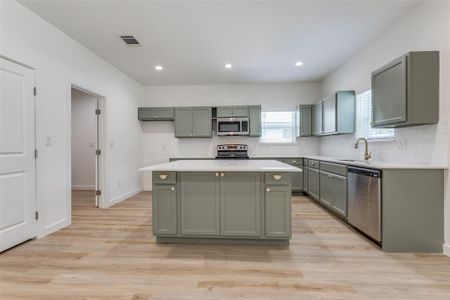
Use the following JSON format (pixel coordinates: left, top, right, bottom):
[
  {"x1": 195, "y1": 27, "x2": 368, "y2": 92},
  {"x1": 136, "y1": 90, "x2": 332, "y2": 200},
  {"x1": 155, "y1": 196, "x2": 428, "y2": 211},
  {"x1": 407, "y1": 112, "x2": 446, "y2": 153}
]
[{"x1": 260, "y1": 111, "x2": 295, "y2": 144}]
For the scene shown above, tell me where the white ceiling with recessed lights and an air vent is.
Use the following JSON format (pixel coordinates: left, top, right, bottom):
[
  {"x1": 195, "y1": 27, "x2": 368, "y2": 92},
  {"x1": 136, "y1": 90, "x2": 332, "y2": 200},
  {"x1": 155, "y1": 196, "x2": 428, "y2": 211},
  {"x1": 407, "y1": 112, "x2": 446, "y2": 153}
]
[{"x1": 21, "y1": 0, "x2": 417, "y2": 85}]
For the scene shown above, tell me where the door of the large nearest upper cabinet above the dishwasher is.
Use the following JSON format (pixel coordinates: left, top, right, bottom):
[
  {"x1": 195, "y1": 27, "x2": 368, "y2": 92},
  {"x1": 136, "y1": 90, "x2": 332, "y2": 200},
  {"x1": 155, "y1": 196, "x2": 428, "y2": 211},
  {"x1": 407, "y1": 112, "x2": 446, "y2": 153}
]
[{"x1": 372, "y1": 56, "x2": 407, "y2": 126}]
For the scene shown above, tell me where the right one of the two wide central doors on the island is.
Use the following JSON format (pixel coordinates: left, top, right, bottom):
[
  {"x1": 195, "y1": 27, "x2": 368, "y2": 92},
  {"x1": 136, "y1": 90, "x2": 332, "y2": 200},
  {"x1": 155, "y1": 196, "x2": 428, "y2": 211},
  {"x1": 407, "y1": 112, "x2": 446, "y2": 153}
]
[{"x1": 220, "y1": 173, "x2": 262, "y2": 237}]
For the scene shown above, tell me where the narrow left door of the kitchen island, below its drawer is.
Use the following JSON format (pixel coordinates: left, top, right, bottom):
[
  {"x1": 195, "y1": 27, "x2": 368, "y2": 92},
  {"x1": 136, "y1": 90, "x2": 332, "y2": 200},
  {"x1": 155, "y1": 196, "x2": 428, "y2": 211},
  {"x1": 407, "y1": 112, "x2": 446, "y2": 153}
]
[{"x1": 153, "y1": 184, "x2": 177, "y2": 236}]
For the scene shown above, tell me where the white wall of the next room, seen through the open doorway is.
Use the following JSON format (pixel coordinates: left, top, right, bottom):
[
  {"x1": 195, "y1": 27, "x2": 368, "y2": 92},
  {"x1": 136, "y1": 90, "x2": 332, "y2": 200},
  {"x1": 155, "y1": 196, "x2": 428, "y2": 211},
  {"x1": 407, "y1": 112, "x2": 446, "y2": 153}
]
[{"x1": 72, "y1": 89, "x2": 97, "y2": 190}]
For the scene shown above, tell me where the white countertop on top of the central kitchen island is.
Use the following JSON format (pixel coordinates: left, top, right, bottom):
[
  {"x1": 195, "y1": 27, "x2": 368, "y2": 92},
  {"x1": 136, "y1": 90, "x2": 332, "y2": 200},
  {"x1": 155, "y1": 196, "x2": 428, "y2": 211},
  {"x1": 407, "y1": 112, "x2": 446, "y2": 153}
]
[{"x1": 139, "y1": 159, "x2": 301, "y2": 172}]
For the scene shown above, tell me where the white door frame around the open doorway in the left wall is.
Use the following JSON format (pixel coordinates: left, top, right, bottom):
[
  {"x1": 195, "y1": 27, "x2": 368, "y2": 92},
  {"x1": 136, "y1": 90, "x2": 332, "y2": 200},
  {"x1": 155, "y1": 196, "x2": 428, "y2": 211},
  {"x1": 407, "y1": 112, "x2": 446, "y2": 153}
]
[{"x1": 68, "y1": 83, "x2": 109, "y2": 209}]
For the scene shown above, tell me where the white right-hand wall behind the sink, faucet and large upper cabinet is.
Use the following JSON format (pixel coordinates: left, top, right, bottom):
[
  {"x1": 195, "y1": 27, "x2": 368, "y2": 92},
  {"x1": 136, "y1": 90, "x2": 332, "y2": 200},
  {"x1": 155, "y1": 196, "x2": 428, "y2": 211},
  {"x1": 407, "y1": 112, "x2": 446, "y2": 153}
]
[{"x1": 320, "y1": 1, "x2": 450, "y2": 254}]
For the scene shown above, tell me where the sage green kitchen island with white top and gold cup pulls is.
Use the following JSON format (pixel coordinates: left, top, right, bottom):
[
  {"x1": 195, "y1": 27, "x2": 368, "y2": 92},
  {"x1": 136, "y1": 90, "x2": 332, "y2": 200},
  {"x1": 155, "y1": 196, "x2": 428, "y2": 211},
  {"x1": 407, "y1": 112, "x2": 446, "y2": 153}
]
[{"x1": 140, "y1": 160, "x2": 301, "y2": 245}]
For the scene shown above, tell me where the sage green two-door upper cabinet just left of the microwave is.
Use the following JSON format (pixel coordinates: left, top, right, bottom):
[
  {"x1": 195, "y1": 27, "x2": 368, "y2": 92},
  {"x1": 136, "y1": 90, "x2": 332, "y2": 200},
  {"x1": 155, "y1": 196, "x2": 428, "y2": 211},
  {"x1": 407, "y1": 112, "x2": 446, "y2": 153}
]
[{"x1": 175, "y1": 107, "x2": 212, "y2": 138}]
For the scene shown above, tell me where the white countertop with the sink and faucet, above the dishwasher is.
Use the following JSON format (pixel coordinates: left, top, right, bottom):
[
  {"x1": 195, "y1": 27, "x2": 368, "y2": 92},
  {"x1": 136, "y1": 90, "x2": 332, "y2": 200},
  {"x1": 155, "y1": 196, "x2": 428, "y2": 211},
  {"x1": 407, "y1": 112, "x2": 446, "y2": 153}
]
[{"x1": 303, "y1": 156, "x2": 448, "y2": 170}]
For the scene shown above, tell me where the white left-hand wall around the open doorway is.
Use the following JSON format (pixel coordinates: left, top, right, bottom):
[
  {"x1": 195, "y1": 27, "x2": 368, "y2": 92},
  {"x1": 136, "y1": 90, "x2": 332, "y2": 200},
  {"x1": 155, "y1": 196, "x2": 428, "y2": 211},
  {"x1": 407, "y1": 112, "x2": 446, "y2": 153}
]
[{"x1": 0, "y1": 1, "x2": 143, "y2": 236}]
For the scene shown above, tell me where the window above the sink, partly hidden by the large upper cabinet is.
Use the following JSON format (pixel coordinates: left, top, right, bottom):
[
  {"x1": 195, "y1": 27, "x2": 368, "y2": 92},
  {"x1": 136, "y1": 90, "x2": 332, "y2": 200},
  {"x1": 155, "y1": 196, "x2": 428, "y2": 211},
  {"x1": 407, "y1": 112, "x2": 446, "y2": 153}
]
[{"x1": 356, "y1": 90, "x2": 394, "y2": 140}]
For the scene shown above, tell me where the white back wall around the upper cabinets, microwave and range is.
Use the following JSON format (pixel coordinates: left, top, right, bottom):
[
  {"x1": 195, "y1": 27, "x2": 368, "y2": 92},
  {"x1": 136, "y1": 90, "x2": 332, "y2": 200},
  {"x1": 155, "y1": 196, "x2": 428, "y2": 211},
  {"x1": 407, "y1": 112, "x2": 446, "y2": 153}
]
[{"x1": 141, "y1": 82, "x2": 320, "y2": 190}]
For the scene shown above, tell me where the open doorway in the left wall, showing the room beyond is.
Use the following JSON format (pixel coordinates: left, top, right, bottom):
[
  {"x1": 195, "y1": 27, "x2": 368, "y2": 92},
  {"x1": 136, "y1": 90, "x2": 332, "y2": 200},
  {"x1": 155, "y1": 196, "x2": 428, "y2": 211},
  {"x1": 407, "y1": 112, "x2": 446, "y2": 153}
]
[{"x1": 71, "y1": 86, "x2": 104, "y2": 210}]
